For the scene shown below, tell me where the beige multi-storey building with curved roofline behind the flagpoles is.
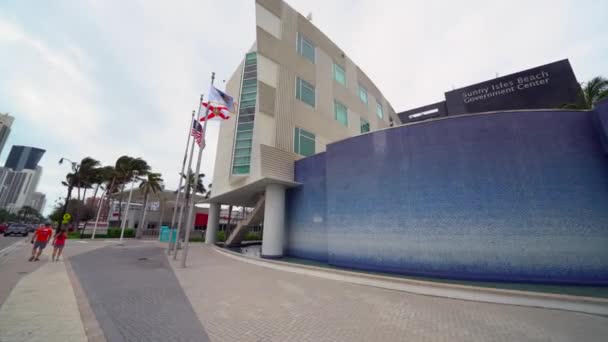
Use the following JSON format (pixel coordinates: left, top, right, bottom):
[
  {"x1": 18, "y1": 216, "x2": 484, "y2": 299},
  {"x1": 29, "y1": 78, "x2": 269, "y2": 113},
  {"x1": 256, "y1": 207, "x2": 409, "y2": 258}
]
[{"x1": 207, "y1": 0, "x2": 399, "y2": 257}]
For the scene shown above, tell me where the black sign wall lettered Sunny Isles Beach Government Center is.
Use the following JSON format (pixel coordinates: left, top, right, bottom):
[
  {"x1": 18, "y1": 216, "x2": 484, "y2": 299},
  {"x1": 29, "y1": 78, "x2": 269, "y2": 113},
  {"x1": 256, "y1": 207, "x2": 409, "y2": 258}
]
[{"x1": 445, "y1": 59, "x2": 580, "y2": 115}]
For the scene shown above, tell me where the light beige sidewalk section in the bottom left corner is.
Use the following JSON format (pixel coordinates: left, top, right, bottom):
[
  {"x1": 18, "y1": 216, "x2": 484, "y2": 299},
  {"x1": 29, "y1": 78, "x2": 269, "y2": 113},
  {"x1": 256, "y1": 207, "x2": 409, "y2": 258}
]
[{"x1": 0, "y1": 262, "x2": 87, "y2": 342}]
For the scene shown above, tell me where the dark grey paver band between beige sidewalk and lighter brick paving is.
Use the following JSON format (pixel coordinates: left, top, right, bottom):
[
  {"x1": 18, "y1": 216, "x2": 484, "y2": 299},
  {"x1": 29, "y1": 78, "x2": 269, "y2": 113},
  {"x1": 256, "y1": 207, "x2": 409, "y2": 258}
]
[{"x1": 70, "y1": 242, "x2": 208, "y2": 342}]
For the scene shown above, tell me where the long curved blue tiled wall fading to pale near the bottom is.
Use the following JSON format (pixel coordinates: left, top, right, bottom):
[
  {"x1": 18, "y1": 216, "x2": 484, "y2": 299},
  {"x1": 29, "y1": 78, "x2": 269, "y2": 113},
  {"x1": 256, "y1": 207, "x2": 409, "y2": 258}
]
[{"x1": 286, "y1": 103, "x2": 608, "y2": 284}]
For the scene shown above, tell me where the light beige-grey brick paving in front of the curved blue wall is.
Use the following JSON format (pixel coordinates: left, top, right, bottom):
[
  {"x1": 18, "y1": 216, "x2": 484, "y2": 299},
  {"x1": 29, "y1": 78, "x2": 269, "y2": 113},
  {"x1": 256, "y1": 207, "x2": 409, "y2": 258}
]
[{"x1": 172, "y1": 245, "x2": 608, "y2": 342}]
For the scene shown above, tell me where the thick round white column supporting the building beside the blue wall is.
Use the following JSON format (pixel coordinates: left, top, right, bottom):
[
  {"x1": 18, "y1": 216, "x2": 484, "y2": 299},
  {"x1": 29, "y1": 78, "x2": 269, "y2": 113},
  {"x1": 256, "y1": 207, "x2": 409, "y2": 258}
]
[{"x1": 262, "y1": 184, "x2": 285, "y2": 258}]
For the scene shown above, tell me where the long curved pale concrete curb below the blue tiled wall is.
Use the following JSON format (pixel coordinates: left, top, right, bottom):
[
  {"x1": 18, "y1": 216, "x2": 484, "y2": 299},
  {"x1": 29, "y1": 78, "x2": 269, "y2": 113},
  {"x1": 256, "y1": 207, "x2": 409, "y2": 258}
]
[{"x1": 213, "y1": 246, "x2": 608, "y2": 316}]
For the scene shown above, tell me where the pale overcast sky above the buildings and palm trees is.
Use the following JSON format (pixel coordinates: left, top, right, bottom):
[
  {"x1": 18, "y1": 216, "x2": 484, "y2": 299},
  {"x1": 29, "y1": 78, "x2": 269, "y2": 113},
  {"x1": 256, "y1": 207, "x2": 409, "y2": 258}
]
[{"x1": 0, "y1": 0, "x2": 608, "y2": 213}]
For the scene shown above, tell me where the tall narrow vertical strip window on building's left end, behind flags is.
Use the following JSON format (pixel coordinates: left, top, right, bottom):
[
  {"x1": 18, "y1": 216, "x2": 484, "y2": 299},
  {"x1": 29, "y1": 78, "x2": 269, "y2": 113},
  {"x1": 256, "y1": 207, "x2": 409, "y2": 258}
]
[{"x1": 232, "y1": 52, "x2": 258, "y2": 175}]
